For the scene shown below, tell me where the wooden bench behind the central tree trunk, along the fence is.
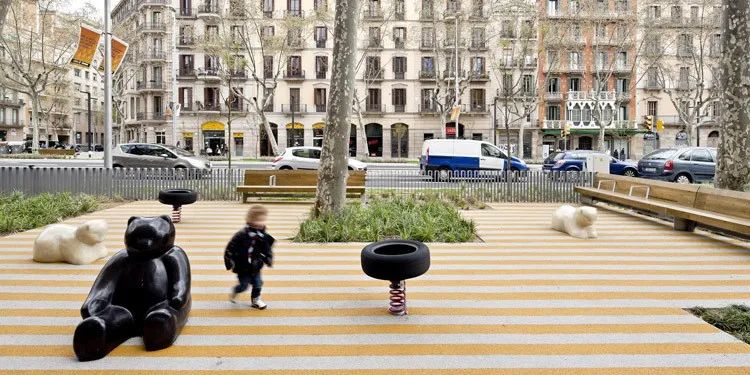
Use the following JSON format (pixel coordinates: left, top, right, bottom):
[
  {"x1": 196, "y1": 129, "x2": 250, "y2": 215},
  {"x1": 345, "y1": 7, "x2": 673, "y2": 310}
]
[{"x1": 236, "y1": 170, "x2": 366, "y2": 203}]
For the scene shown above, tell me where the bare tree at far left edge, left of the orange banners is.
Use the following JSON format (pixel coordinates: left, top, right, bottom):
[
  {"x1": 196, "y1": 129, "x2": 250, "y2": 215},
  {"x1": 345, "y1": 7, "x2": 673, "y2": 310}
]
[{"x1": 0, "y1": 0, "x2": 79, "y2": 153}]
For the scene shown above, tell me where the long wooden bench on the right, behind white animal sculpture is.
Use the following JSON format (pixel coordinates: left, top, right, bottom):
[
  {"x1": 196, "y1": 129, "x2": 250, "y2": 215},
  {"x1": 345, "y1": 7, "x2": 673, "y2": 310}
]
[{"x1": 576, "y1": 173, "x2": 750, "y2": 238}]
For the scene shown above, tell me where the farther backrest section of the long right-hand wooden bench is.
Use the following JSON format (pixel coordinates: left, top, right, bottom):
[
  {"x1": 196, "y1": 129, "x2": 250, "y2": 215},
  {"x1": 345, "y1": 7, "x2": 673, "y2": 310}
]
[{"x1": 594, "y1": 173, "x2": 700, "y2": 207}]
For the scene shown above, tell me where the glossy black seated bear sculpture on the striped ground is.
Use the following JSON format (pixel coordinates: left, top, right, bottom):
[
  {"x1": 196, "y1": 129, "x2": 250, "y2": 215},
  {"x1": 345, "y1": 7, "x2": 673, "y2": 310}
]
[{"x1": 73, "y1": 216, "x2": 191, "y2": 361}]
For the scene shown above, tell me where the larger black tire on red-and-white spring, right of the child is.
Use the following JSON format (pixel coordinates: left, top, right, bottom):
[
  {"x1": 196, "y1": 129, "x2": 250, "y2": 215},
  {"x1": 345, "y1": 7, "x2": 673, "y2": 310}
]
[{"x1": 361, "y1": 240, "x2": 430, "y2": 281}]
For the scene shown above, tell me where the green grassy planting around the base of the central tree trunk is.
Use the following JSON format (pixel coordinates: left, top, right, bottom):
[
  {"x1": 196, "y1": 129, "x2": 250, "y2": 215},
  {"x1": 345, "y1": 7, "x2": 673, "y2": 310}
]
[{"x1": 294, "y1": 193, "x2": 476, "y2": 242}]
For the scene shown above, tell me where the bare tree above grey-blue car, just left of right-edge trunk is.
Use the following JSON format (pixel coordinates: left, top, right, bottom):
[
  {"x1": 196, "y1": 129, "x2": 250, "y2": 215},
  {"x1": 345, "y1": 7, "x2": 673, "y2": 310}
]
[{"x1": 642, "y1": 0, "x2": 721, "y2": 145}]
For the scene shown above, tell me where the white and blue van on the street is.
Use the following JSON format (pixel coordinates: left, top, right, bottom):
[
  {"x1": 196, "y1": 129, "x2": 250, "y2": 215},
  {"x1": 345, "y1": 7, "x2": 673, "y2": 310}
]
[{"x1": 419, "y1": 139, "x2": 506, "y2": 180}]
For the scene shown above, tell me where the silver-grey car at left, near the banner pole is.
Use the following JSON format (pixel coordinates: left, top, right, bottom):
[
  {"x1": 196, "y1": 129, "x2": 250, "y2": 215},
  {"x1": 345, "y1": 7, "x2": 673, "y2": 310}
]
[{"x1": 112, "y1": 143, "x2": 211, "y2": 170}]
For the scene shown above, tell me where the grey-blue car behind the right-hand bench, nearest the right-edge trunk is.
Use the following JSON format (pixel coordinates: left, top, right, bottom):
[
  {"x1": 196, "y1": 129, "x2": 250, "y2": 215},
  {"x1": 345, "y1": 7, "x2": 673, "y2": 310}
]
[{"x1": 638, "y1": 147, "x2": 716, "y2": 184}]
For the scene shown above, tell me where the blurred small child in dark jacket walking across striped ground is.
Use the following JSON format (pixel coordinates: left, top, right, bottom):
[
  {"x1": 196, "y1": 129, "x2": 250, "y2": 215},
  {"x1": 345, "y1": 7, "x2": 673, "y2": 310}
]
[{"x1": 224, "y1": 205, "x2": 275, "y2": 310}]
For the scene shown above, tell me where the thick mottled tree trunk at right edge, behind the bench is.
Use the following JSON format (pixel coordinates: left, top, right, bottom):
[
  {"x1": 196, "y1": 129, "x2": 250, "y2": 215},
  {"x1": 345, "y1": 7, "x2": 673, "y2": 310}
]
[{"x1": 716, "y1": 0, "x2": 750, "y2": 191}]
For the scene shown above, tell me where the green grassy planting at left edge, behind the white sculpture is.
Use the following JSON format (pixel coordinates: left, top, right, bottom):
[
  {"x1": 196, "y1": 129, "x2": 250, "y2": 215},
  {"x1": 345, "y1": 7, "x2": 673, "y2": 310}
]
[{"x1": 0, "y1": 193, "x2": 99, "y2": 234}]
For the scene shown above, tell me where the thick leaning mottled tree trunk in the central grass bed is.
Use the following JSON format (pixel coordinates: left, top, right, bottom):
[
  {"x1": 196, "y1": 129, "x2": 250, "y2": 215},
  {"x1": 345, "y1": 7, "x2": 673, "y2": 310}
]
[{"x1": 314, "y1": 0, "x2": 359, "y2": 216}]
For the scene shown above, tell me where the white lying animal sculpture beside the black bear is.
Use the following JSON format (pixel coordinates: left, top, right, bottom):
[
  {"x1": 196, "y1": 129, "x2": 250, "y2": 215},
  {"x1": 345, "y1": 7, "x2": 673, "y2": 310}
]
[{"x1": 33, "y1": 220, "x2": 107, "y2": 265}]
